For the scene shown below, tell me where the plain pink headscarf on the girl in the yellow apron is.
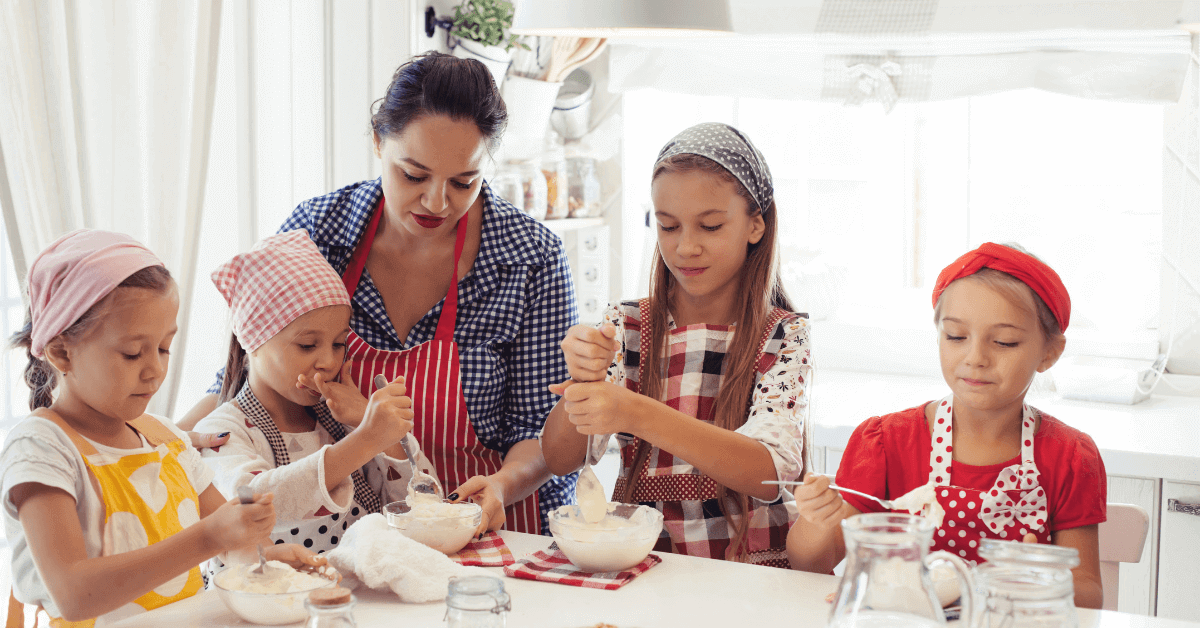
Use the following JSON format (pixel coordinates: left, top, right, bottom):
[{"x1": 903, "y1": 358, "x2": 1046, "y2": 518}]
[{"x1": 28, "y1": 229, "x2": 164, "y2": 358}]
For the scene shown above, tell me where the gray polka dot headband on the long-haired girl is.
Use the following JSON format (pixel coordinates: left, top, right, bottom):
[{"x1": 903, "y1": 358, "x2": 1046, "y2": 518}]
[{"x1": 654, "y1": 122, "x2": 775, "y2": 213}]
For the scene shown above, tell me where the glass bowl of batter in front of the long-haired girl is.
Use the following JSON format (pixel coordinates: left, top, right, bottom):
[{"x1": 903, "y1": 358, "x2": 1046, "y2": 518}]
[{"x1": 550, "y1": 502, "x2": 662, "y2": 573}]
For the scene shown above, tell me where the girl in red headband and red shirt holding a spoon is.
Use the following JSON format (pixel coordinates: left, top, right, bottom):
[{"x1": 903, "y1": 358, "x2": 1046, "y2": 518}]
[{"x1": 787, "y1": 243, "x2": 1106, "y2": 608}]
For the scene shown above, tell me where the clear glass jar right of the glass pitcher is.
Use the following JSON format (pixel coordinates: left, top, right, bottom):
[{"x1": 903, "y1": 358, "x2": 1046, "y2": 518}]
[{"x1": 971, "y1": 539, "x2": 1079, "y2": 628}]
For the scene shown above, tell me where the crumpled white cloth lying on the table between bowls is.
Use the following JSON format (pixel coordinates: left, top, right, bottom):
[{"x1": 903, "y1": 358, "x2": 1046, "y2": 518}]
[{"x1": 329, "y1": 513, "x2": 494, "y2": 604}]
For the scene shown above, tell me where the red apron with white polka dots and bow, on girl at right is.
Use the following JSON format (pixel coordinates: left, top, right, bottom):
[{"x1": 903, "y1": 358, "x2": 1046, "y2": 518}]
[{"x1": 929, "y1": 395, "x2": 1050, "y2": 564}]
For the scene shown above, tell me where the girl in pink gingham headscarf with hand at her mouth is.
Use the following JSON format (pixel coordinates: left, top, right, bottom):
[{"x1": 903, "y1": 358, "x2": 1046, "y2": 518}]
[{"x1": 196, "y1": 229, "x2": 424, "y2": 554}]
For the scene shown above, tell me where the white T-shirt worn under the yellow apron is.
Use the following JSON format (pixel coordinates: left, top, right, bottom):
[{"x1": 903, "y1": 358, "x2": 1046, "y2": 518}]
[{"x1": 0, "y1": 417, "x2": 212, "y2": 627}]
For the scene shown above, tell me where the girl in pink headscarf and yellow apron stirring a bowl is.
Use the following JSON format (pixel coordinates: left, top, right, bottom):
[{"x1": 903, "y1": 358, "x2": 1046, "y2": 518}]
[{"x1": 0, "y1": 229, "x2": 312, "y2": 626}]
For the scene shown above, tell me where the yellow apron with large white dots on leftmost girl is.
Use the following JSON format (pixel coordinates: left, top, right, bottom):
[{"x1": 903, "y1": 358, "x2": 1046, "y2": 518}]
[{"x1": 10, "y1": 412, "x2": 204, "y2": 628}]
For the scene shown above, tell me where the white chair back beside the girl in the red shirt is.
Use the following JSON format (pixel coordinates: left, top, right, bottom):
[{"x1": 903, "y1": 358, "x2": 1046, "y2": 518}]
[{"x1": 1109, "y1": 476, "x2": 1159, "y2": 615}]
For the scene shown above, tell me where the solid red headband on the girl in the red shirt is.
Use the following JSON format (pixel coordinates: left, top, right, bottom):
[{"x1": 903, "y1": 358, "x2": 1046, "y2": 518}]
[{"x1": 934, "y1": 243, "x2": 1070, "y2": 331}]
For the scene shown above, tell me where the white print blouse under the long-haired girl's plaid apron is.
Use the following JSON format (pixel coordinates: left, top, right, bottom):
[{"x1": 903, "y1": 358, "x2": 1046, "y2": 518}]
[{"x1": 600, "y1": 305, "x2": 812, "y2": 506}]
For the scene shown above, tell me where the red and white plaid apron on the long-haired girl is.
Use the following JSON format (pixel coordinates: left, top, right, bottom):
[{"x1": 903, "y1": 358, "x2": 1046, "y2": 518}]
[{"x1": 613, "y1": 299, "x2": 797, "y2": 569}]
